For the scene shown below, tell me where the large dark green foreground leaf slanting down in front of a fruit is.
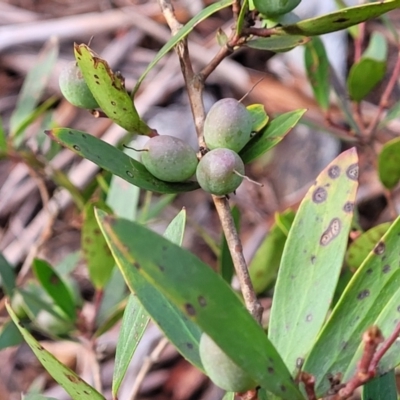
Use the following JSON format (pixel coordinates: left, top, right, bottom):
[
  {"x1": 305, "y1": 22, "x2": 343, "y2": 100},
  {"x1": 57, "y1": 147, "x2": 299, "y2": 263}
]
[{"x1": 98, "y1": 212, "x2": 303, "y2": 400}]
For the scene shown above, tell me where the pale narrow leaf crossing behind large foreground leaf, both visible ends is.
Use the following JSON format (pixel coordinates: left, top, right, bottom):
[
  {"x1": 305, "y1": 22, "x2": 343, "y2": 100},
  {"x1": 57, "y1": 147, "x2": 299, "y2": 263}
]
[{"x1": 112, "y1": 210, "x2": 186, "y2": 398}]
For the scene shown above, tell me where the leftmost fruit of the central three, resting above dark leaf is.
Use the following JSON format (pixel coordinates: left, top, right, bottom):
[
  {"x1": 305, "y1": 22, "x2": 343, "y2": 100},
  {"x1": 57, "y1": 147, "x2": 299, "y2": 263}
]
[{"x1": 141, "y1": 135, "x2": 198, "y2": 182}]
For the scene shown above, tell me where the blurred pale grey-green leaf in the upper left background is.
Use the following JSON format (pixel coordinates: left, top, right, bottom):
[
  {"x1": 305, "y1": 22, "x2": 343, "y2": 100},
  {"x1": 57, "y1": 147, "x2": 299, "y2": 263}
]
[{"x1": 10, "y1": 38, "x2": 58, "y2": 138}]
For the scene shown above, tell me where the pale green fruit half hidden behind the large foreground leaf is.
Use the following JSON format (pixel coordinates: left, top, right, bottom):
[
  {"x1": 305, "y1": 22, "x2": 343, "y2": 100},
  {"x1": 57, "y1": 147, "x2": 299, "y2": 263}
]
[{"x1": 199, "y1": 333, "x2": 257, "y2": 393}]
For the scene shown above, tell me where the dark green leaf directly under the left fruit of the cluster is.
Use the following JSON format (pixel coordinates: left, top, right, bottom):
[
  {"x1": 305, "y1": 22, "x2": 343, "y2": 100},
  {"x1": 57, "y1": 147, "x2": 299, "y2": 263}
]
[{"x1": 46, "y1": 128, "x2": 199, "y2": 193}]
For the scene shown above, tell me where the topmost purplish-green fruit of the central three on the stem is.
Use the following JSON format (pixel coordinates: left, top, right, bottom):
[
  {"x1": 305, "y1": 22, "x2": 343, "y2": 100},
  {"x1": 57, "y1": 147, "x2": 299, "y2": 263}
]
[{"x1": 204, "y1": 99, "x2": 253, "y2": 152}]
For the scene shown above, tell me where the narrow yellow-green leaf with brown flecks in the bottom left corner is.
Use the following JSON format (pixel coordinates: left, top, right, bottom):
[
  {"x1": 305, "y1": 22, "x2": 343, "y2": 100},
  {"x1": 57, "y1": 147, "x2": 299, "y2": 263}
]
[{"x1": 6, "y1": 303, "x2": 104, "y2": 400}]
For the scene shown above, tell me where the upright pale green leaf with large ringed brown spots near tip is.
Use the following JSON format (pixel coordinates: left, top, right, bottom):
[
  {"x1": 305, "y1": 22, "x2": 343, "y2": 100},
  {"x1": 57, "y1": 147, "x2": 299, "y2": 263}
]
[{"x1": 268, "y1": 148, "x2": 358, "y2": 373}]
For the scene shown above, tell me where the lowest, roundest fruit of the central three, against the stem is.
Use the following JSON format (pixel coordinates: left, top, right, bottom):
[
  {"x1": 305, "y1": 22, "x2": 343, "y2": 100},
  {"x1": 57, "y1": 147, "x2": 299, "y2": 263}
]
[{"x1": 196, "y1": 149, "x2": 244, "y2": 196}]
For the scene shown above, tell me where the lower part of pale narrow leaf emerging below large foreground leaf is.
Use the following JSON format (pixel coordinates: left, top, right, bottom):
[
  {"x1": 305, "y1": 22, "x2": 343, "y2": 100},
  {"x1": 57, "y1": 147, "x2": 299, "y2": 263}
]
[{"x1": 112, "y1": 294, "x2": 149, "y2": 398}]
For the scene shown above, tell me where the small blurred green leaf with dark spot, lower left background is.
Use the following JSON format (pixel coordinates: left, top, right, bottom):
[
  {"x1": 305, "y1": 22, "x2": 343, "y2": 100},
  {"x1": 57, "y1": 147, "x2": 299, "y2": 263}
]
[{"x1": 32, "y1": 258, "x2": 76, "y2": 321}]
